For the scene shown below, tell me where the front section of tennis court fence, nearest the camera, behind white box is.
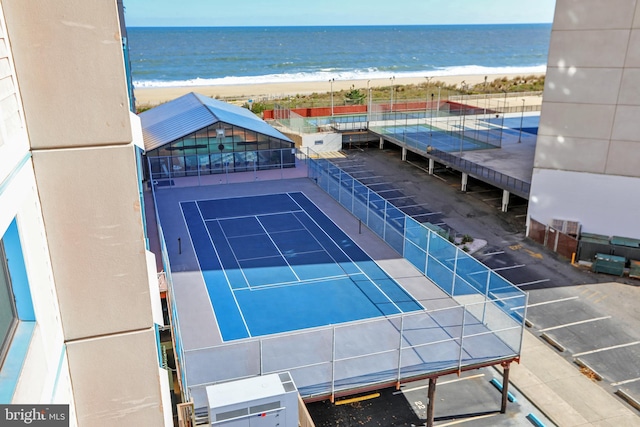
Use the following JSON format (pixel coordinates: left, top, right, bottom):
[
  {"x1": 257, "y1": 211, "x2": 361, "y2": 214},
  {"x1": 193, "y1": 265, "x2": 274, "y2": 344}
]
[{"x1": 185, "y1": 295, "x2": 526, "y2": 411}]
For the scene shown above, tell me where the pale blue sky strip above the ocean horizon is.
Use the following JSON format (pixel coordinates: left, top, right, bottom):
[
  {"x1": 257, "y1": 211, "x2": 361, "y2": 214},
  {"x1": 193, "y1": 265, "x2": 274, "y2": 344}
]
[{"x1": 123, "y1": 0, "x2": 555, "y2": 27}]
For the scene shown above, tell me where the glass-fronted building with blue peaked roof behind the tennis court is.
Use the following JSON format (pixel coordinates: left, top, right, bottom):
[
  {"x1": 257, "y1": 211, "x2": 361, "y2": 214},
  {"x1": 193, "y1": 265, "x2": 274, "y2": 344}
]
[{"x1": 139, "y1": 92, "x2": 295, "y2": 178}]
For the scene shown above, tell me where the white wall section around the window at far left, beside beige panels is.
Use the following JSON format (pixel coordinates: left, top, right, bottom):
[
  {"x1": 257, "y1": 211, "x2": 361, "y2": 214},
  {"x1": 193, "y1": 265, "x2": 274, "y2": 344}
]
[{"x1": 0, "y1": 3, "x2": 75, "y2": 425}]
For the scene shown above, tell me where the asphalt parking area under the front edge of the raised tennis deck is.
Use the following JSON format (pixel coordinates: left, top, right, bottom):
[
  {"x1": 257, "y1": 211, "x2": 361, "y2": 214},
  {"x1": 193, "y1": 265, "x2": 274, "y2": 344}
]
[{"x1": 308, "y1": 368, "x2": 554, "y2": 427}]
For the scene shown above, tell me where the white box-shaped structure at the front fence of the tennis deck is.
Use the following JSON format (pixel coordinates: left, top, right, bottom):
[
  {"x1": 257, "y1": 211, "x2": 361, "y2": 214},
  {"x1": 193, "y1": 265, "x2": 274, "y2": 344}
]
[{"x1": 207, "y1": 372, "x2": 298, "y2": 427}]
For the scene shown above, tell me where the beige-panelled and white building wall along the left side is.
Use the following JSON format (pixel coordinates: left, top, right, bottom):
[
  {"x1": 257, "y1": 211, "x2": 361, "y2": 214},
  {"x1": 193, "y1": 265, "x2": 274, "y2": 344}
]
[{"x1": 0, "y1": 0, "x2": 172, "y2": 427}]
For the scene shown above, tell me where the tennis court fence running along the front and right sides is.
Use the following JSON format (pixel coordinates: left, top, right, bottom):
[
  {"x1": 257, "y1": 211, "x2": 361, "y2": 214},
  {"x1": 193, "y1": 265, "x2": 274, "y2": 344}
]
[{"x1": 160, "y1": 153, "x2": 527, "y2": 412}]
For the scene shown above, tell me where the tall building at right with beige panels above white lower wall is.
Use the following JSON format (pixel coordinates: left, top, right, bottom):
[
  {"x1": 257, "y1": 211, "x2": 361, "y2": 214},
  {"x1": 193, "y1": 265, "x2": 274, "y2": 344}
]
[{"x1": 529, "y1": 0, "x2": 640, "y2": 238}]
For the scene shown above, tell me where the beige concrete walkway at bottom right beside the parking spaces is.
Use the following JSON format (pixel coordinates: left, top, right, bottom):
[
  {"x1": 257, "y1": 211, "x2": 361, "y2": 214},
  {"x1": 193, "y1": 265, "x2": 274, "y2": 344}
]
[{"x1": 499, "y1": 331, "x2": 640, "y2": 427}]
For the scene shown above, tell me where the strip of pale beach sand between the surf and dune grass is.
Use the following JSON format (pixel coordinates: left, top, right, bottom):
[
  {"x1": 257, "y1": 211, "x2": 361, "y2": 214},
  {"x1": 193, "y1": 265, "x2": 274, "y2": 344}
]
[{"x1": 134, "y1": 73, "x2": 543, "y2": 107}]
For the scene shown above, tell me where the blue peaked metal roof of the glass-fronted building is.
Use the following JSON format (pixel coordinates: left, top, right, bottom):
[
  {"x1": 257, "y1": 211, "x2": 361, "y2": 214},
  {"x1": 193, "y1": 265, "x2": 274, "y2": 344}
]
[{"x1": 139, "y1": 92, "x2": 293, "y2": 151}]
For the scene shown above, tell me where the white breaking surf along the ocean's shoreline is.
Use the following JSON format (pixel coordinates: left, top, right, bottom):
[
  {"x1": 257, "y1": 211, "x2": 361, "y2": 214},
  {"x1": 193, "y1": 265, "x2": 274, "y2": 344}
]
[{"x1": 133, "y1": 64, "x2": 547, "y2": 88}]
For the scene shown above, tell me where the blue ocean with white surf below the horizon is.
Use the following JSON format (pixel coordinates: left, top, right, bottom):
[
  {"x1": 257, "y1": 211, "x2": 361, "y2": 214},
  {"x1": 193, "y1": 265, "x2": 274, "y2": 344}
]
[{"x1": 127, "y1": 24, "x2": 551, "y2": 87}]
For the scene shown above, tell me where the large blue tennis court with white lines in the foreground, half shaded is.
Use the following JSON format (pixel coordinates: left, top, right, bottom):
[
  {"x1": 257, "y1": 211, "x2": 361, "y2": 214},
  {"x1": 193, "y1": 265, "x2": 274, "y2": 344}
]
[{"x1": 180, "y1": 192, "x2": 422, "y2": 341}]
